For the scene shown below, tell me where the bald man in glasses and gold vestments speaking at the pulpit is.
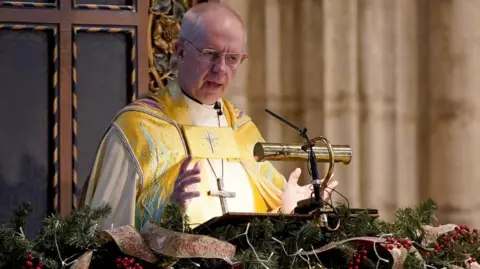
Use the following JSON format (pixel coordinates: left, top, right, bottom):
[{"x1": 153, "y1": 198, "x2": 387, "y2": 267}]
[{"x1": 80, "y1": 3, "x2": 337, "y2": 229}]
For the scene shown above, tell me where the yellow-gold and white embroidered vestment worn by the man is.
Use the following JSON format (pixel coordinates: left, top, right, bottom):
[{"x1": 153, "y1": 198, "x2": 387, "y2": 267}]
[{"x1": 81, "y1": 80, "x2": 285, "y2": 229}]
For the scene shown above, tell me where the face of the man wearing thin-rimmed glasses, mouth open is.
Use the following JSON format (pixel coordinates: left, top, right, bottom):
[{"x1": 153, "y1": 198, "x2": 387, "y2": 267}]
[{"x1": 177, "y1": 16, "x2": 246, "y2": 104}]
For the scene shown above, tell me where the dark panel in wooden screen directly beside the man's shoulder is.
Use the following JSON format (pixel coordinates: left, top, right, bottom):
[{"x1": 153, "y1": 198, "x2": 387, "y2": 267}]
[{"x1": 73, "y1": 28, "x2": 137, "y2": 205}]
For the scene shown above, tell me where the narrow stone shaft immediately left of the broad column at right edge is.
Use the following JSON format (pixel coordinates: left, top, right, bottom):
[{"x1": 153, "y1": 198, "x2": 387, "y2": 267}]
[{"x1": 394, "y1": 0, "x2": 425, "y2": 207}]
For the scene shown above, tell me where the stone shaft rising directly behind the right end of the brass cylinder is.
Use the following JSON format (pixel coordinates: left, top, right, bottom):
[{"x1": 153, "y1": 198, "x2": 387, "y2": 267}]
[{"x1": 322, "y1": 0, "x2": 363, "y2": 207}]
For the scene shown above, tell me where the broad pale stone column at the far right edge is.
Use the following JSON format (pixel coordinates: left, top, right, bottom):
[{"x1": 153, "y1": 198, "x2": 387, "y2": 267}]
[{"x1": 429, "y1": 0, "x2": 480, "y2": 225}]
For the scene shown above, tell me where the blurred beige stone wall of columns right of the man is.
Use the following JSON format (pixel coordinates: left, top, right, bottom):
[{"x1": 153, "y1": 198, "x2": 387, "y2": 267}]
[{"x1": 221, "y1": 0, "x2": 480, "y2": 225}]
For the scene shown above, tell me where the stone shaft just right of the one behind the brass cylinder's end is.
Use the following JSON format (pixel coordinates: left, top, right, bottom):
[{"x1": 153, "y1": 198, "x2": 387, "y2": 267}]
[{"x1": 357, "y1": 0, "x2": 397, "y2": 220}]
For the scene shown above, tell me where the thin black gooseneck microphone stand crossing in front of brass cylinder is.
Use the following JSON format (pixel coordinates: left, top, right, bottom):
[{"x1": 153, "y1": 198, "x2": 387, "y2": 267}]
[{"x1": 265, "y1": 109, "x2": 324, "y2": 211}]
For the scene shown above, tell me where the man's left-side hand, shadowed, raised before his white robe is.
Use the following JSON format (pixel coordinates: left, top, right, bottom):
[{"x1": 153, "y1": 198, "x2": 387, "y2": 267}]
[{"x1": 170, "y1": 156, "x2": 201, "y2": 210}]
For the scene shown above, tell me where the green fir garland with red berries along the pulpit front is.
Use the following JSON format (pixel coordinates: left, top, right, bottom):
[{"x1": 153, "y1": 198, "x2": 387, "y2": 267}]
[{"x1": 0, "y1": 200, "x2": 480, "y2": 269}]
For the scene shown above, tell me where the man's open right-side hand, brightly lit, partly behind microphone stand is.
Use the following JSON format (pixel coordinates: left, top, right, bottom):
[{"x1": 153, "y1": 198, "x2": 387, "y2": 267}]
[{"x1": 282, "y1": 168, "x2": 338, "y2": 214}]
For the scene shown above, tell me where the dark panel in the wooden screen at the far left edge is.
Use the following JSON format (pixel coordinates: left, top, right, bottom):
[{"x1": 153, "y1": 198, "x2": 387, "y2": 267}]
[{"x1": 0, "y1": 25, "x2": 59, "y2": 236}]
